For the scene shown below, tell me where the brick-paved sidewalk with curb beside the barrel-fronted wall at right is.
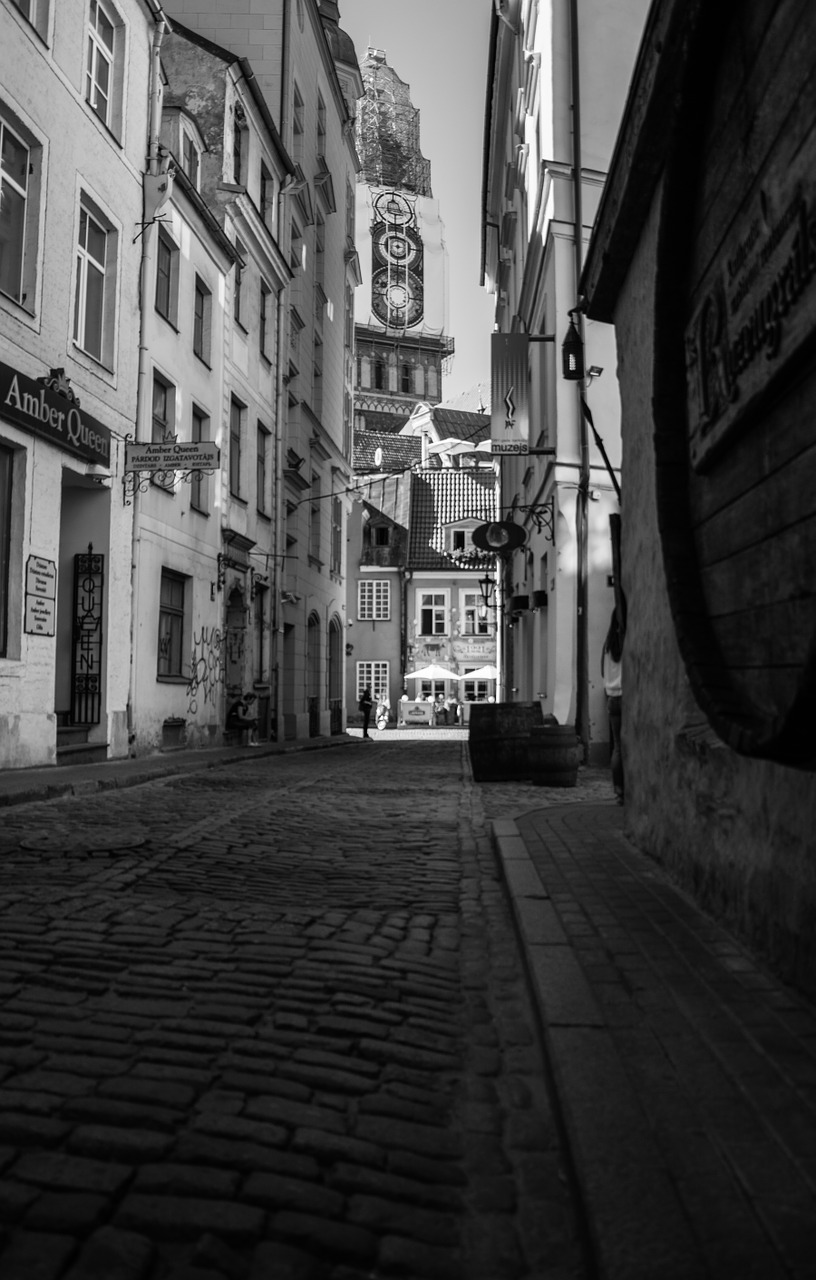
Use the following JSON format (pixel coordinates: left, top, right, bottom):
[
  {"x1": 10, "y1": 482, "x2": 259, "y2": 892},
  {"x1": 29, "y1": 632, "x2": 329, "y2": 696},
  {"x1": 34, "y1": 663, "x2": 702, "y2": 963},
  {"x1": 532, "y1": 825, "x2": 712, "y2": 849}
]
[{"x1": 492, "y1": 804, "x2": 816, "y2": 1280}]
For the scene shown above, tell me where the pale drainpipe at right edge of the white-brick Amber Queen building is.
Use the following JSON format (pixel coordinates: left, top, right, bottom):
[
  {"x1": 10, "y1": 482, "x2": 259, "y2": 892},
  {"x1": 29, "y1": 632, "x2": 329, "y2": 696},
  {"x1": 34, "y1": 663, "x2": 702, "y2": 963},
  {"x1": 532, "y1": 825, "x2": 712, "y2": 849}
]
[{"x1": 123, "y1": 4, "x2": 169, "y2": 754}]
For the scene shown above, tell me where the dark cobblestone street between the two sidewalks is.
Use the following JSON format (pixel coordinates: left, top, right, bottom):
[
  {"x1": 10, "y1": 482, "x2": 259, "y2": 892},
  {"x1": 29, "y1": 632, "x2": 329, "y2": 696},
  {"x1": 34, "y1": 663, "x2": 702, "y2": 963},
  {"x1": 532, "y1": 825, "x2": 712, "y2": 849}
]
[{"x1": 0, "y1": 735, "x2": 598, "y2": 1280}]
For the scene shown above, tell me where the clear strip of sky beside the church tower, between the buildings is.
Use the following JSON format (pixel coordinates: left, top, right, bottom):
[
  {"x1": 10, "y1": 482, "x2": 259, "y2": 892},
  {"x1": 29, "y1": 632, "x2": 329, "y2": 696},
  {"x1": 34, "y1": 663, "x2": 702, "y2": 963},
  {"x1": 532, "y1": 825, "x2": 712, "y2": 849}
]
[{"x1": 339, "y1": 0, "x2": 494, "y2": 399}]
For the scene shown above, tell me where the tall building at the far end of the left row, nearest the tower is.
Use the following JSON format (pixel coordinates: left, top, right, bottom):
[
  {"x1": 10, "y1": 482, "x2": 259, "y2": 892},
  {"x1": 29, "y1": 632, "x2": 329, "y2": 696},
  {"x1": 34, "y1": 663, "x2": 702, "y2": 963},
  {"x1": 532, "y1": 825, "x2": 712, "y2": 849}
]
[{"x1": 166, "y1": 0, "x2": 362, "y2": 737}]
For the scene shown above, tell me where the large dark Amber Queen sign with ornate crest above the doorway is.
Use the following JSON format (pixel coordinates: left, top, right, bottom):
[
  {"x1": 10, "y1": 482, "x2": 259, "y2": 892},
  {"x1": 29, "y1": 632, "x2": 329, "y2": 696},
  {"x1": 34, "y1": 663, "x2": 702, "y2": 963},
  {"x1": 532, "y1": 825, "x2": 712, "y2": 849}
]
[{"x1": 0, "y1": 364, "x2": 110, "y2": 467}]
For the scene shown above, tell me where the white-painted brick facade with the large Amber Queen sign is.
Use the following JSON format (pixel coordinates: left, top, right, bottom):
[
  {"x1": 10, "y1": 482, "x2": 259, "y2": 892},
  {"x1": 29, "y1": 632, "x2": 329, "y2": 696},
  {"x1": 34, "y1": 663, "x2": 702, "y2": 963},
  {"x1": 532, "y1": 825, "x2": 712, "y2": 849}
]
[{"x1": 0, "y1": 0, "x2": 164, "y2": 768}]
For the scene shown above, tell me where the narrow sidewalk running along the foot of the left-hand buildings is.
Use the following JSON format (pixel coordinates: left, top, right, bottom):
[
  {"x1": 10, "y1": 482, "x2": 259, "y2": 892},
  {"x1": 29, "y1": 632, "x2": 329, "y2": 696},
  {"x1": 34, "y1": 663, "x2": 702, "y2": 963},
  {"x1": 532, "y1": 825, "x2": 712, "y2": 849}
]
[{"x1": 0, "y1": 733, "x2": 353, "y2": 809}]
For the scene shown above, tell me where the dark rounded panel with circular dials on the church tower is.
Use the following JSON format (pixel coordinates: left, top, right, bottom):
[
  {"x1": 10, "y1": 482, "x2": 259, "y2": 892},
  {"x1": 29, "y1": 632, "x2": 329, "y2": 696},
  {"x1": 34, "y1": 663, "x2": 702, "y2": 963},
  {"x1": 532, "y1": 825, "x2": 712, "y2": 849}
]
[{"x1": 371, "y1": 191, "x2": 425, "y2": 329}]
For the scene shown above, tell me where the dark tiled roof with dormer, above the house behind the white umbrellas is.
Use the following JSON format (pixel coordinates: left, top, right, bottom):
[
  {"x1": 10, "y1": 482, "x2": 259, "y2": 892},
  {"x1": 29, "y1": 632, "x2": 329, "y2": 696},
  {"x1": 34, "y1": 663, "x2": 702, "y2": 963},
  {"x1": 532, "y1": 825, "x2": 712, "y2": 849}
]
[{"x1": 408, "y1": 467, "x2": 499, "y2": 568}]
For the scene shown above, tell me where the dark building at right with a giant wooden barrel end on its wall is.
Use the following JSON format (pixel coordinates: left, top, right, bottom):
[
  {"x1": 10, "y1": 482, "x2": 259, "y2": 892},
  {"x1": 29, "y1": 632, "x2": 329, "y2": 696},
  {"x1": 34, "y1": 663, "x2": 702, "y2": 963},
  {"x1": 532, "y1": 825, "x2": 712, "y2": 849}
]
[{"x1": 582, "y1": 0, "x2": 816, "y2": 995}]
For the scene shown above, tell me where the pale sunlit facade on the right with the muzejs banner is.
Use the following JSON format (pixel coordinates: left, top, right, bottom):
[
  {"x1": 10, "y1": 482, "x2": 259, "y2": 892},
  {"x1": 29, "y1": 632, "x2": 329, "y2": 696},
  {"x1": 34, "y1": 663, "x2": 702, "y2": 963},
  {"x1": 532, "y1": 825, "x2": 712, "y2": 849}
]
[{"x1": 482, "y1": 0, "x2": 646, "y2": 760}]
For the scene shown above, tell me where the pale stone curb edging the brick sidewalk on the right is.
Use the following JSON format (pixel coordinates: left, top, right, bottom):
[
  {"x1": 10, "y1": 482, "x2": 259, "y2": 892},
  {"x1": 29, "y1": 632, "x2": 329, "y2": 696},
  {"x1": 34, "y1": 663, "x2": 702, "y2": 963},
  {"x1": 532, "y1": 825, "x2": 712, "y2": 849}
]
[{"x1": 490, "y1": 818, "x2": 705, "y2": 1280}]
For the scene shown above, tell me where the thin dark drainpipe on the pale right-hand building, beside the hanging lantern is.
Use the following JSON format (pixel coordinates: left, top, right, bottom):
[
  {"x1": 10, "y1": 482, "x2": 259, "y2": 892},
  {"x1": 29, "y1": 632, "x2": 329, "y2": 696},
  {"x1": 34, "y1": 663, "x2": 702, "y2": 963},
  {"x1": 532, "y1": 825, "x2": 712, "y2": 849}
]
[{"x1": 569, "y1": 0, "x2": 590, "y2": 760}]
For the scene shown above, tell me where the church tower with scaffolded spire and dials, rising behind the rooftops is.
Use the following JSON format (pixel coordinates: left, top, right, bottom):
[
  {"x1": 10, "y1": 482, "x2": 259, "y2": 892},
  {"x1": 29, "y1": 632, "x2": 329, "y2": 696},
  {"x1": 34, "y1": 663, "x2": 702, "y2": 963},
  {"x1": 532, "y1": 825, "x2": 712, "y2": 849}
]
[{"x1": 354, "y1": 49, "x2": 454, "y2": 431}]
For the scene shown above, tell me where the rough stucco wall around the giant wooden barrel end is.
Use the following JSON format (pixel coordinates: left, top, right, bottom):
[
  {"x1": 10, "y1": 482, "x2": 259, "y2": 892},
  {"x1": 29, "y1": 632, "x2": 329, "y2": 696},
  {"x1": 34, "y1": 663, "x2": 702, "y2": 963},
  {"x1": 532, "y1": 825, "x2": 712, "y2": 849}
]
[{"x1": 615, "y1": 180, "x2": 816, "y2": 995}]
